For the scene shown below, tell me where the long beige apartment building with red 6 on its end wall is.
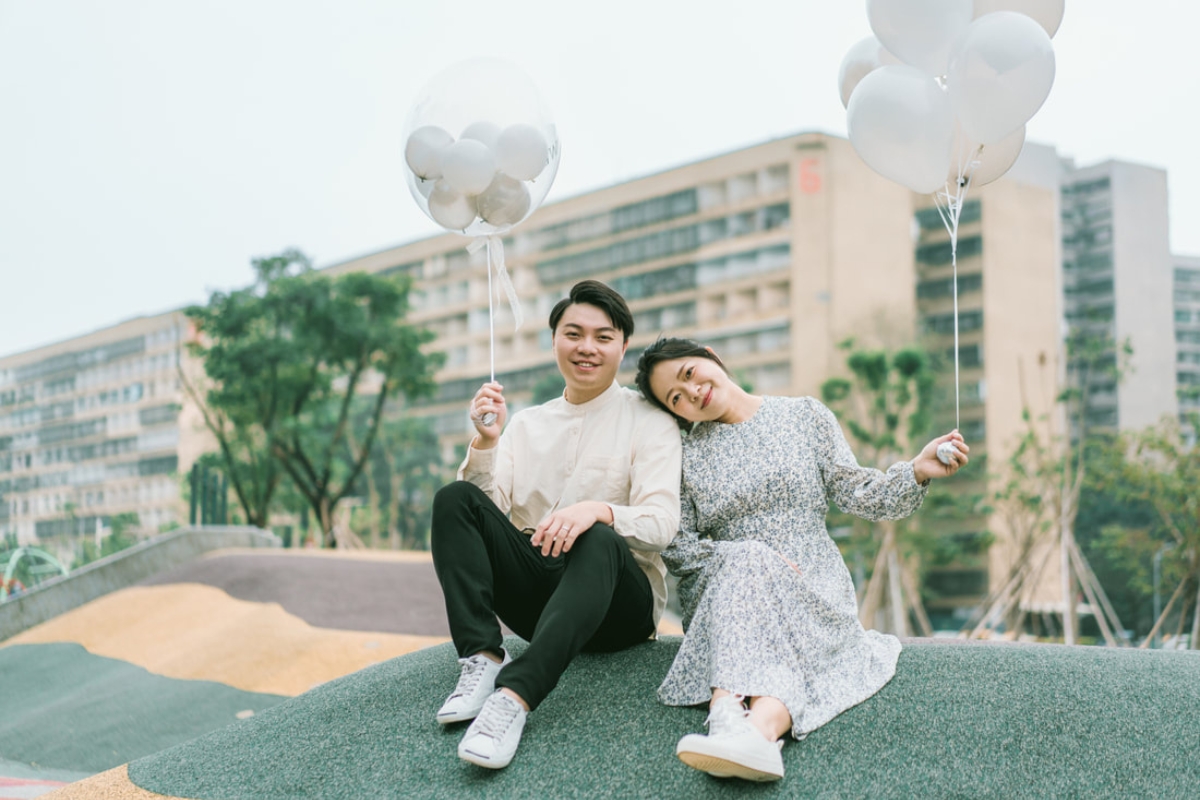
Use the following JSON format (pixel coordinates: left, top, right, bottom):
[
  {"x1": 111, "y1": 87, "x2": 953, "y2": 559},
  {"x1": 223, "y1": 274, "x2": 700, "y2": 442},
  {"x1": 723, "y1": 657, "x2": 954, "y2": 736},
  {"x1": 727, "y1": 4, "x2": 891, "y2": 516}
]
[{"x1": 329, "y1": 133, "x2": 916, "y2": 455}]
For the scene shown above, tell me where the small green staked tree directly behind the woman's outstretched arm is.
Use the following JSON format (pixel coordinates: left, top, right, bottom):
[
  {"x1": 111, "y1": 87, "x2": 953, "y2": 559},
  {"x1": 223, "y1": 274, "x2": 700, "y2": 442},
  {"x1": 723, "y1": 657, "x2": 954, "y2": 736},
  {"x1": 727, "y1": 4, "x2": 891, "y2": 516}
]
[{"x1": 821, "y1": 339, "x2": 934, "y2": 636}]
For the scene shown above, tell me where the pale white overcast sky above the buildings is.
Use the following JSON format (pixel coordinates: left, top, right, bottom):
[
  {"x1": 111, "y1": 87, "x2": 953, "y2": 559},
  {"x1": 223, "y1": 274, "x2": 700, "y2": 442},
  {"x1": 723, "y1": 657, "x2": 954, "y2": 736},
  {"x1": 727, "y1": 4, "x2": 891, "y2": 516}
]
[{"x1": 0, "y1": 0, "x2": 1200, "y2": 355}]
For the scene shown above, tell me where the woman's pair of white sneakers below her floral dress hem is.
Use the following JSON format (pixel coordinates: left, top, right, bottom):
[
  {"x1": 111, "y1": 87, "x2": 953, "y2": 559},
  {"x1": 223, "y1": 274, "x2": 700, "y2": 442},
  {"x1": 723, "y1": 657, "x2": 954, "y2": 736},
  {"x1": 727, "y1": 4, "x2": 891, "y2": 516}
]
[{"x1": 676, "y1": 694, "x2": 784, "y2": 781}]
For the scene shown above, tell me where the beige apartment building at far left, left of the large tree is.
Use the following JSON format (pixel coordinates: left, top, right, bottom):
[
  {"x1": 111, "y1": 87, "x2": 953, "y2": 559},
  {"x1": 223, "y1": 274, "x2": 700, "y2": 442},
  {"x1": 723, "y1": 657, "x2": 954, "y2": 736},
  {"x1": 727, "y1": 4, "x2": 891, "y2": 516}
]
[{"x1": 0, "y1": 313, "x2": 205, "y2": 564}]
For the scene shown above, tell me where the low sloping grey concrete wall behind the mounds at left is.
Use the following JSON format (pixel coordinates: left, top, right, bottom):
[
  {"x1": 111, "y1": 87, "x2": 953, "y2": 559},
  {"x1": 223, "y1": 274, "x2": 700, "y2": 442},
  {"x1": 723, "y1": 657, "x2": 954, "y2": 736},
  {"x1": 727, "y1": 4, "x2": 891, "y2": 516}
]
[{"x1": 0, "y1": 525, "x2": 280, "y2": 642}]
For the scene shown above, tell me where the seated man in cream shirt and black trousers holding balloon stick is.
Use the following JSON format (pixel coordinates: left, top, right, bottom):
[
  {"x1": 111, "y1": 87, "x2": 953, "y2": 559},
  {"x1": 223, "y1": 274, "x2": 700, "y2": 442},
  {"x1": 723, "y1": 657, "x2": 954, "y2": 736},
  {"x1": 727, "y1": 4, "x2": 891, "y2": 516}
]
[{"x1": 432, "y1": 281, "x2": 680, "y2": 769}]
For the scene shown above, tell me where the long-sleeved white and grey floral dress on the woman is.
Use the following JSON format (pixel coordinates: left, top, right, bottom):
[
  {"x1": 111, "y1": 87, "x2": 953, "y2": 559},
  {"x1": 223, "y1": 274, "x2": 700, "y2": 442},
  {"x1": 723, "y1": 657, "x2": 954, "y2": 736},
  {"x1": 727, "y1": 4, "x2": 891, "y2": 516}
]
[{"x1": 659, "y1": 397, "x2": 926, "y2": 739}]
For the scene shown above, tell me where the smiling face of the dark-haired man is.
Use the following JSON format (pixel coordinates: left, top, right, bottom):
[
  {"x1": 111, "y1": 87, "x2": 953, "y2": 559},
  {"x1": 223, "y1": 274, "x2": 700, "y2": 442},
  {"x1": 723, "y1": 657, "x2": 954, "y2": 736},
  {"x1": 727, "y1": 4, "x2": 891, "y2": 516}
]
[{"x1": 554, "y1": 303, "x2": 629, "y2": 403}]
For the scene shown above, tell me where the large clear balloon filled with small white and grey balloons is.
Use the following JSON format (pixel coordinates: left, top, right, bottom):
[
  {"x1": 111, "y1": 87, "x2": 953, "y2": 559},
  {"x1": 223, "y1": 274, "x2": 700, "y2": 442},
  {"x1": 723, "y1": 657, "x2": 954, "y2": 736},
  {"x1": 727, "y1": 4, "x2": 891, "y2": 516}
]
[{"x1": 403, "y1": 58, "x2": 562, "y2": 236}]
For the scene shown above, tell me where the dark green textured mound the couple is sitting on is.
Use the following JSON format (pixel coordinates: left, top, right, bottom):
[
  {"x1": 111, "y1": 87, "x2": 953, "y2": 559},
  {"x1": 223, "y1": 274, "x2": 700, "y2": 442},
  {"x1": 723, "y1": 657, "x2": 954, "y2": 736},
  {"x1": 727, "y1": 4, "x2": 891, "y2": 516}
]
[{"x1": 128, "y1": 638, "x2": 1200, "y2": 800}]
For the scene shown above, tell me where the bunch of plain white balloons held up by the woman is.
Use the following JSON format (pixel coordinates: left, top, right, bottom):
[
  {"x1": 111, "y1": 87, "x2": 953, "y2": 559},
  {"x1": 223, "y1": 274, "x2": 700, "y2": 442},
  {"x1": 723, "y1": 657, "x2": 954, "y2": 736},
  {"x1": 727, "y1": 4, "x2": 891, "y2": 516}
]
[{"x1": 838, "y1": 0, "x2": 1064, "y2": 193}]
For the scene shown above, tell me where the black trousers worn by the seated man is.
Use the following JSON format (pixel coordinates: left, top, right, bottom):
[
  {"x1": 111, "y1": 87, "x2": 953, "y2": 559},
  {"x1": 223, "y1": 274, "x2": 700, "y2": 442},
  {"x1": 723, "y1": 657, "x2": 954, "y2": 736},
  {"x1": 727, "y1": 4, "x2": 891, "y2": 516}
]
[{"x1": 431, "y1": 481, "x2": 654, "y2": 709}]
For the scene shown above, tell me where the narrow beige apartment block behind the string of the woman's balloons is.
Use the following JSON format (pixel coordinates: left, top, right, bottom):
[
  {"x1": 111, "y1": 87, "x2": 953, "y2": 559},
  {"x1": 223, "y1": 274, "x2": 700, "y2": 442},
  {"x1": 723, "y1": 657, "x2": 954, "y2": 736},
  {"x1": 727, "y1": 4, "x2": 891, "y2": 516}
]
[{"x1": 914, "y1": 144, "x2": 1062, "y2": 628}]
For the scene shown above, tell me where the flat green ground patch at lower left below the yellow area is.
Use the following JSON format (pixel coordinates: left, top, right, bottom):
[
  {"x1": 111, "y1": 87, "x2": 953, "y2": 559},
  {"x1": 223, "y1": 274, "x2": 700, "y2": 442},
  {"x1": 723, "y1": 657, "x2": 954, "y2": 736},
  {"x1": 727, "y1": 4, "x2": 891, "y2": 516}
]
[{"x1": 0, "y1": 643, "x2": 286, "y2": 775}]
